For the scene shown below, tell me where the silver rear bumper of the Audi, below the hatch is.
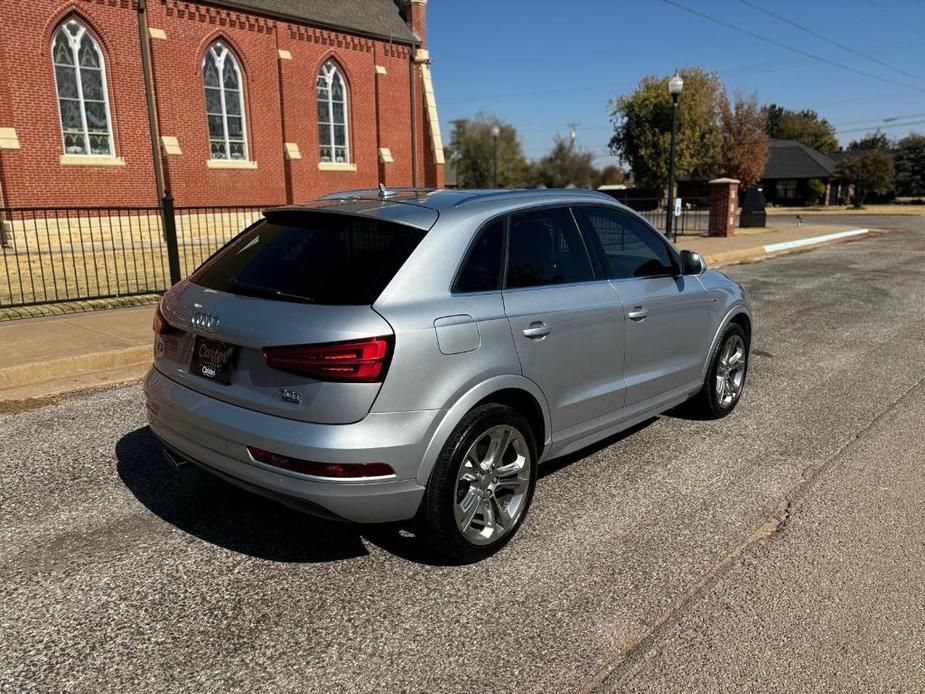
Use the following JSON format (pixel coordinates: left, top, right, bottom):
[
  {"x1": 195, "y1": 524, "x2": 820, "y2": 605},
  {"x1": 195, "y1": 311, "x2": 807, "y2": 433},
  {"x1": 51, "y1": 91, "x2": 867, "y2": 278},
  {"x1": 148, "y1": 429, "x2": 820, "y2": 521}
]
[{"x1": 144, "y1": 368, "x2": 441, "y2": 523}]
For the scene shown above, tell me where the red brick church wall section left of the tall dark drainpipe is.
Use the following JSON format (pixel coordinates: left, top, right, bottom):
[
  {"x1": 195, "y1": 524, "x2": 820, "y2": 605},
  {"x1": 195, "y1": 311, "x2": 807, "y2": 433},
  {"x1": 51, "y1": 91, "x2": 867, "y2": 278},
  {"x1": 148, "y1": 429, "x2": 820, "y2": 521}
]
[{"x1": 0, "y1": 0, "x2": 157, "y2": 206}]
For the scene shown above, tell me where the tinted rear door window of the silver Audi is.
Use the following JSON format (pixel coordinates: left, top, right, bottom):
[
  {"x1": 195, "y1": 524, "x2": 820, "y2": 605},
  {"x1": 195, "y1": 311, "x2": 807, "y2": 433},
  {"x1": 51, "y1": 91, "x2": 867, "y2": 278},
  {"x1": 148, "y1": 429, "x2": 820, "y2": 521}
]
[{"x1": 507, "y1": 208, "x2": 594, "y2": 287}]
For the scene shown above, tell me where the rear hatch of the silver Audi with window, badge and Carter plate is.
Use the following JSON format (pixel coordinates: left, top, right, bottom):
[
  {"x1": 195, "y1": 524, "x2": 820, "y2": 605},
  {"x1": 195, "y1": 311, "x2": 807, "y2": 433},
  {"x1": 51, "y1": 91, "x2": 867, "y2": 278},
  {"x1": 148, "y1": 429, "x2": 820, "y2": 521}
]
[{"x1": 155, "y1": 205, "x2": 436, "y2": 424}]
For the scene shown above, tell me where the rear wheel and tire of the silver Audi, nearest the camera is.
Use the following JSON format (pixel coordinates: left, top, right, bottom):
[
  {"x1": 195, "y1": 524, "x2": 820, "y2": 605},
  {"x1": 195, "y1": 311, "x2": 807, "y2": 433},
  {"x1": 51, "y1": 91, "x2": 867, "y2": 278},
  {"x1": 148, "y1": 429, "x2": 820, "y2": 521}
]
[{"x1": 421, "y1": 403, "x2": 537, "y2": 562}]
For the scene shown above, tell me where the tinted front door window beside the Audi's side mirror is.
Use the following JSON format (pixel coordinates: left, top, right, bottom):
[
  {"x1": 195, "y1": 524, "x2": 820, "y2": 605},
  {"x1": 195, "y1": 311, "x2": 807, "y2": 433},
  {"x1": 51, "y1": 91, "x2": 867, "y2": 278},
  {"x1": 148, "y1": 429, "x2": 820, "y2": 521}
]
[{"x1": 575, "y1": 207, "x2": 674, "y2": 279}]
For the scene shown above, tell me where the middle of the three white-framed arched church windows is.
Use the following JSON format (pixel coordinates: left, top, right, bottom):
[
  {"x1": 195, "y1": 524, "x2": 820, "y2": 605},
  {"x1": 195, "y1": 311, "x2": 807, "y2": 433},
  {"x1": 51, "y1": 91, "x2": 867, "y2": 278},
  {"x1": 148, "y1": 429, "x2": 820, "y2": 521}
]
[{"x1": 202, "y1": 41, "x2": 247, "y2": 160}]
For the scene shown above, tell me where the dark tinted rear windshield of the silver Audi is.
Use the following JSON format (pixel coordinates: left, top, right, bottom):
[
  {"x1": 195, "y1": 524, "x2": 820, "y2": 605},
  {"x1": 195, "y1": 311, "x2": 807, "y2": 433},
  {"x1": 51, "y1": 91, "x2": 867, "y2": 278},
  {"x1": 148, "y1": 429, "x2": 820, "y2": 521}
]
[{"x1": 190, "y1": 213, "x2": 424, "y2": 305}]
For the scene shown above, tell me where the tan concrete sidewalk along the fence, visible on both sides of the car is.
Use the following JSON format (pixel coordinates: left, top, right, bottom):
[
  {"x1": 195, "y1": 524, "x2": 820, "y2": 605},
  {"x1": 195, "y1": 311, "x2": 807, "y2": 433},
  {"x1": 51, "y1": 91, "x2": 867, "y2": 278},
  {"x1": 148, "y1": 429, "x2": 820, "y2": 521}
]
[{"x1": 0, "y1": 225, "x2": 880, "y2": 402}]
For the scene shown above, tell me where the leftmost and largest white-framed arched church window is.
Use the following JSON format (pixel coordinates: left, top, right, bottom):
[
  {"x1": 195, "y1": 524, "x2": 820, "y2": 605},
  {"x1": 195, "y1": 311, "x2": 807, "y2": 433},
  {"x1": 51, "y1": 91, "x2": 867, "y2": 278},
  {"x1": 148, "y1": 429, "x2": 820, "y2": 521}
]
[{"x1": 51, "y1": 19, "x2": 114, "y2": 157}]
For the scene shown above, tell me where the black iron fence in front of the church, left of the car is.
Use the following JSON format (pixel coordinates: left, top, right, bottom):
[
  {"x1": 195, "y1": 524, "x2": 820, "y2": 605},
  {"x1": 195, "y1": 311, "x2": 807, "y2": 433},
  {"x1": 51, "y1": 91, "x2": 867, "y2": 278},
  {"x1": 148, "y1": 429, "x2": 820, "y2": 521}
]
[{"x1": 0, "y1": 196, "x2": 272, "y2": 308}]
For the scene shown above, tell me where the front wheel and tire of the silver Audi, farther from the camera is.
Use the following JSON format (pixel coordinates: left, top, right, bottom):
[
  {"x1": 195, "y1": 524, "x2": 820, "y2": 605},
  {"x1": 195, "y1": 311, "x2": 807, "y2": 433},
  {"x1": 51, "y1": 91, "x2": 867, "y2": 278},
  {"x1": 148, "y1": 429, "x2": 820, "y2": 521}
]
[{"x1": 686, "y1": 323, "x2": 749, "y2": 419}]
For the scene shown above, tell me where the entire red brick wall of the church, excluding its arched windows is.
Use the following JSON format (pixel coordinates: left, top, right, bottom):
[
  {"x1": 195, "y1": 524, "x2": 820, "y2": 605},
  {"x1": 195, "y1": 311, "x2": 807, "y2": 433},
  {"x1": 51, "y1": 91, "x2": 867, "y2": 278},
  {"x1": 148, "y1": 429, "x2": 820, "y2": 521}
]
[{"x1": 0, "y1": 0, "x2": 442, "y2": 206}]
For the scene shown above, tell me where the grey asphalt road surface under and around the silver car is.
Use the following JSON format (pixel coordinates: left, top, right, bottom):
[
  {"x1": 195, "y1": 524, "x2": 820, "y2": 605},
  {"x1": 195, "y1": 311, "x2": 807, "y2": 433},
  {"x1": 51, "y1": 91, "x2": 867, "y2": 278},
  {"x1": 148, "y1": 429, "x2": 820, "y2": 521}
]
[{"x1": 0, "y1": 218, "x2": 925, "y2": 693}]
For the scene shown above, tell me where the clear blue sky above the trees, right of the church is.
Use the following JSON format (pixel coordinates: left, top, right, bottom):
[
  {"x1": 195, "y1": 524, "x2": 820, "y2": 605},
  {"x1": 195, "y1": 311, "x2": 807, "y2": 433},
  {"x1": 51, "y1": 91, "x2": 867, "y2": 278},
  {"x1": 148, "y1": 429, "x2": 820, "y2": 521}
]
[{"x1": 427, "y1": 0, "x2": 925, "y2": 166}]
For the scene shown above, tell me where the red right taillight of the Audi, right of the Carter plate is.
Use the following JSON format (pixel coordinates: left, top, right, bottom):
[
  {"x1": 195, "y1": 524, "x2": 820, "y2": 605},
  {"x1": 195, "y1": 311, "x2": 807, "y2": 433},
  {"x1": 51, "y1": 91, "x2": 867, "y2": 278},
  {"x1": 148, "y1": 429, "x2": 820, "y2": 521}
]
[{"x1": 263, "y1": 335, "x2": 392, "y2": 383}]
